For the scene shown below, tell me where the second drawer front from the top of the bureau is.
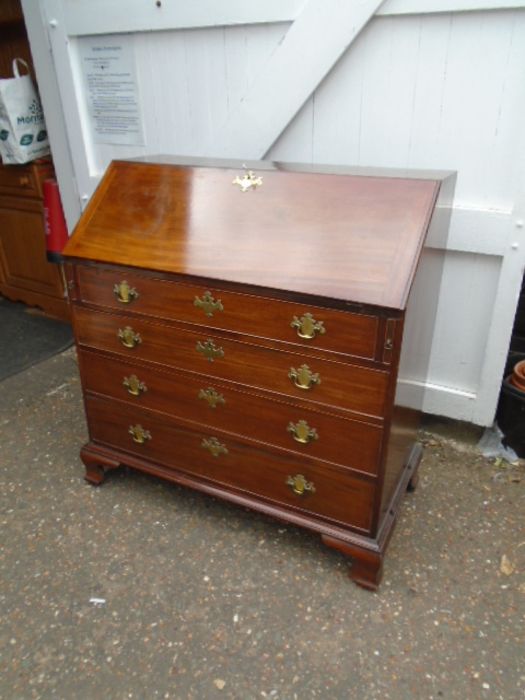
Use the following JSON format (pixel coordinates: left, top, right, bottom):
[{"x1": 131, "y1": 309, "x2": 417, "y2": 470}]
[{"x1": 74, "y1": 308, "x2": 389, "y2": 418}]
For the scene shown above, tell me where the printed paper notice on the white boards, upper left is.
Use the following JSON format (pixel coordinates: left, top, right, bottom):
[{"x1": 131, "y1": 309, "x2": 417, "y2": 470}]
[{"x1": 79, "y1": 37, "x2": 144, "y2": 146}]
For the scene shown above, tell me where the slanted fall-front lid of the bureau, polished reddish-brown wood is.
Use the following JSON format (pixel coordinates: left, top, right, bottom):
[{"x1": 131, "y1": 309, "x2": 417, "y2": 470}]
[{"x1": 64, "y1": 161, "x2": 446, "y2": 309}]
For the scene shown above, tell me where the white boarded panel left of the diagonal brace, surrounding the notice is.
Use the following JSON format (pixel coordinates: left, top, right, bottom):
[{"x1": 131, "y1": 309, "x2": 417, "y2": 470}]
[{"x1": 70, "y1": 24, "x2": 288, "y2": 180}]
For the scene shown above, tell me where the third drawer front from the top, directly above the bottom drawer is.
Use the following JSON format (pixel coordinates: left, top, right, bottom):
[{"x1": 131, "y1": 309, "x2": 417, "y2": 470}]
[{"x1": 79, "y1": 352, "x2": 383, "y2": 474}]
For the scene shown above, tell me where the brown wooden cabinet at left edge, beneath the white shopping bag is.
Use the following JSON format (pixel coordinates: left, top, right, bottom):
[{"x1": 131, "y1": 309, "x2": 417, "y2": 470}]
[{"x1": 0, "y1": 162, "x2": 69, "y2": 320}]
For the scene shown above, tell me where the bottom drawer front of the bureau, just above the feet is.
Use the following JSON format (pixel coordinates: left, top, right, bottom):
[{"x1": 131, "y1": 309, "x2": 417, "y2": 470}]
[{"x1": 86, "y1": 397, "x2": 375, "y2": 532}]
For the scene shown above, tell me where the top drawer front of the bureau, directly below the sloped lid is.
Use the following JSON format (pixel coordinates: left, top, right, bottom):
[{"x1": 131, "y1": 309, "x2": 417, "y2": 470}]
[{"x1": 77, "y1": 266, "x2": 379, "y2": 359}]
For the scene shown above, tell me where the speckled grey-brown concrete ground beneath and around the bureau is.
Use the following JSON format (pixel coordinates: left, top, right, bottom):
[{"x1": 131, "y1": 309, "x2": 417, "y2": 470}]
[{"x1": 0, "y1": 350, "x2": 525, "y2": 700}]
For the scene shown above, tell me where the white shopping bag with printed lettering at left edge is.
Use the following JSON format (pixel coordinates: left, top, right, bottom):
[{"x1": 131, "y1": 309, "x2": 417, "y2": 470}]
[{"x1": 0, "y1": 58, "x2": 49, "y2": 164}]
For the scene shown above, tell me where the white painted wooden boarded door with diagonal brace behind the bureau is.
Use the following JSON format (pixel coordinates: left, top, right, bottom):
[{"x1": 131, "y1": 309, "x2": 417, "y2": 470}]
[{"x1": 23, "y1": 0, "x2": 525, "y2": 425}]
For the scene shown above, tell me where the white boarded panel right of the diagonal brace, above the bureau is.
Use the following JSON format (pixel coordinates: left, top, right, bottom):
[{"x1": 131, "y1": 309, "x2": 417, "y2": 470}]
[{"x1": 270, "y1": 12, "x2": 525, "y2": 211}]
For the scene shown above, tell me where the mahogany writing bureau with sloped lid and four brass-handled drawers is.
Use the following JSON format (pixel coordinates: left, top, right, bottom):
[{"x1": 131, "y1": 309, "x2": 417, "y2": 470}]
[{"x1": 64, "y1": 159, "x2": 454, "y2": 588}]
